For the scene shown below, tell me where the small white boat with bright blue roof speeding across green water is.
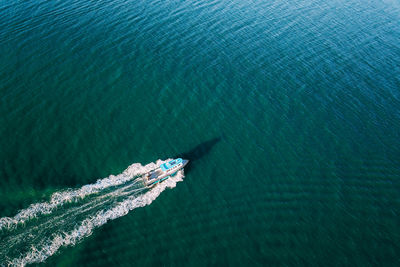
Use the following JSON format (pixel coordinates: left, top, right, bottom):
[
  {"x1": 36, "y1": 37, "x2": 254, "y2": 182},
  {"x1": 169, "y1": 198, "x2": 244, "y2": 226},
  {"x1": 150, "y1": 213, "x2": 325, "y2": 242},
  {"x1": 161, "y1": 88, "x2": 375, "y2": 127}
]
[{"x1": 144, "y1": 158, "x2": 189, "y2": 187}]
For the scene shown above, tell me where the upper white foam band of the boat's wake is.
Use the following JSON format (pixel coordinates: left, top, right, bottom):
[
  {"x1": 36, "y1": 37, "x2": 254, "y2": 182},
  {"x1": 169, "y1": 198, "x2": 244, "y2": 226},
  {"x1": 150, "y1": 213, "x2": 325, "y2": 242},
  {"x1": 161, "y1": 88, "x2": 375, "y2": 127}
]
[{"x1": 0, "y1": 163, "x2": 157, "y2": 230}]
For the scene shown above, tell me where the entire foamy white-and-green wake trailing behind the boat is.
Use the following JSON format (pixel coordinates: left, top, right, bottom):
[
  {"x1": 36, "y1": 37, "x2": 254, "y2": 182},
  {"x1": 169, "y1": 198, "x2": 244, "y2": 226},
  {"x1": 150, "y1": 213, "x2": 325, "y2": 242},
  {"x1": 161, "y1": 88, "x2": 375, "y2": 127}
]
[{"x1": 0, "y1": 159, "x2": 184, "y2": 266}]
